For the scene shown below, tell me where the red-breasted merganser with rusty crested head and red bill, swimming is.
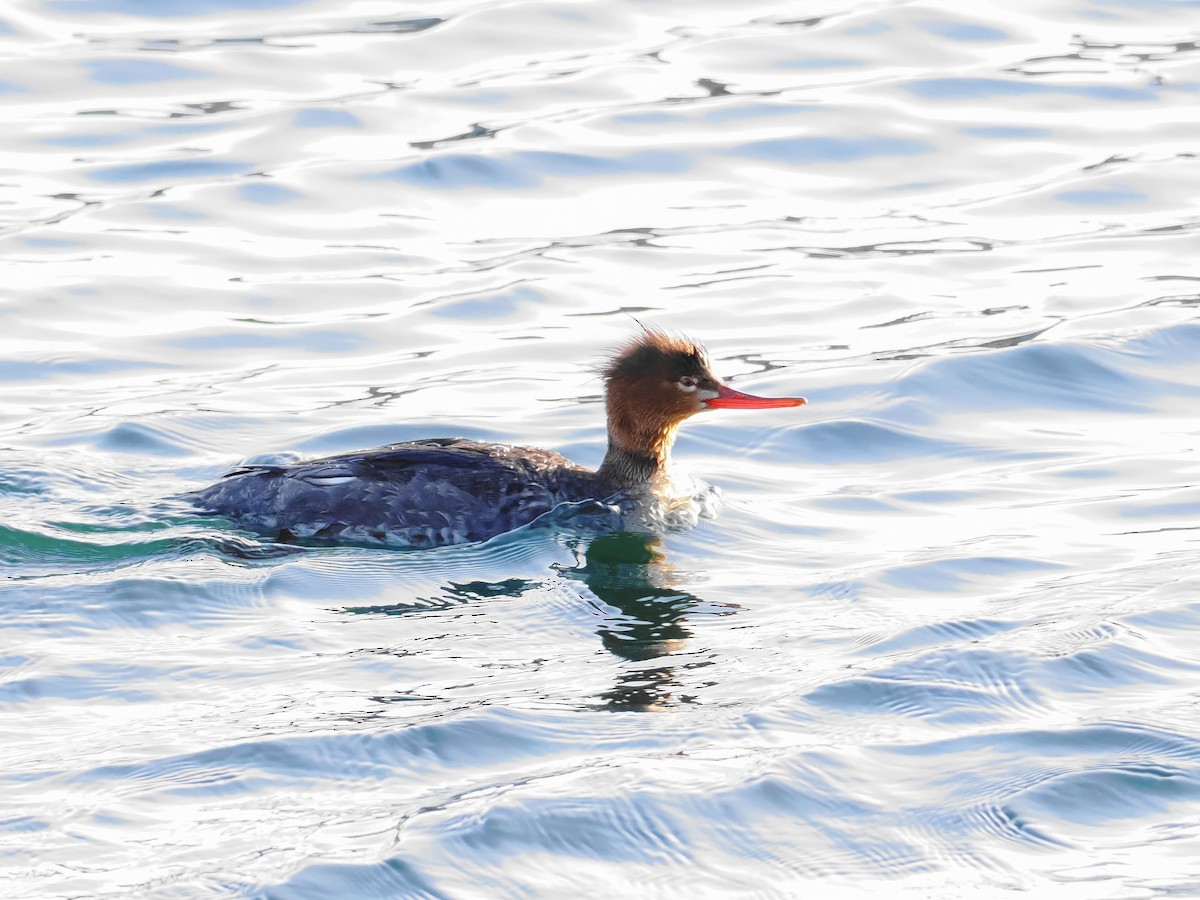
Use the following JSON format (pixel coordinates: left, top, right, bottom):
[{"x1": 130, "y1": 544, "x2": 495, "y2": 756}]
[{"x1": 190, "y1": 331, "x2": 804, "y2": 548}]
